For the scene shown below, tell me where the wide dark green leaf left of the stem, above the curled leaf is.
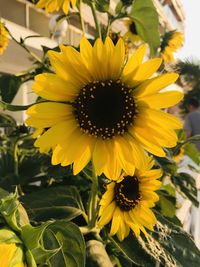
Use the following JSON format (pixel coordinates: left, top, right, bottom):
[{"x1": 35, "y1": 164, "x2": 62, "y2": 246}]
[{"x1": 22, "y1": 186, "x2": 85, "y2": 221}]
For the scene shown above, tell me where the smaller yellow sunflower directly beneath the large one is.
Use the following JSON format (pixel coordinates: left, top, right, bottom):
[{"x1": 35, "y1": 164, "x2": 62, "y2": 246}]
[{"x1": 98, "y1": 157, "x2": 162, "y2": 241}]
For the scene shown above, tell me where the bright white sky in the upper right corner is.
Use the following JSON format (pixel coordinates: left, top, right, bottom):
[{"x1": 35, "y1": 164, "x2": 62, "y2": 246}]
[{"x1": 176, "y1": 0, "x2": 200, "y2": 60}]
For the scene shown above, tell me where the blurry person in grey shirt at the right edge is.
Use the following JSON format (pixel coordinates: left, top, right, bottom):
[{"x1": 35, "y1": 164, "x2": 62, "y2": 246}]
[{"x1": 183, "y1": 98, "x2": 200, "y2": 151}]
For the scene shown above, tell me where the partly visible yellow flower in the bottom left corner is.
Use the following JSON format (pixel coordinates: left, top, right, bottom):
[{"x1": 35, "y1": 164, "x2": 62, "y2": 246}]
[{"x1": 0, "y1": 243, "x2": 25, "y2": 267}]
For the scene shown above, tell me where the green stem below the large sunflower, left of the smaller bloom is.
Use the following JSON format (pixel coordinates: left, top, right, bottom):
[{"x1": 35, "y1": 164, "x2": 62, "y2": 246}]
[{"x1": 88, "y1": 174, "x2": 98, "y2": 228}]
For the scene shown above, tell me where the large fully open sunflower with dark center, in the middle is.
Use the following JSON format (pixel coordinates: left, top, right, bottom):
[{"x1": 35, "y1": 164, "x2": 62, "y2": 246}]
[{"x1": 26, "y1": 38, "x2": 182, "y2": 179}]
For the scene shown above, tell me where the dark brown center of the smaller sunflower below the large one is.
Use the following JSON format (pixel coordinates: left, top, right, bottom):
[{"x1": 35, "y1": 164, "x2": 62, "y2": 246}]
[{"x1": 114, "y1": 176, "x2": 141, "y2": 211}]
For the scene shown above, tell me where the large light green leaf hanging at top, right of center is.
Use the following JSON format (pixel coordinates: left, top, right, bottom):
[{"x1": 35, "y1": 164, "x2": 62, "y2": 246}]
[{"x1": 130, "y1": 0, "x2": 160, "y2": 56}]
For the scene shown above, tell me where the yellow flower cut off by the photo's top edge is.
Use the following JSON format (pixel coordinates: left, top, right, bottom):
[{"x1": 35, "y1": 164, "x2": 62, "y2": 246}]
[{"x1": 36, "y1": 0, "x2": 76, "y2": 14}]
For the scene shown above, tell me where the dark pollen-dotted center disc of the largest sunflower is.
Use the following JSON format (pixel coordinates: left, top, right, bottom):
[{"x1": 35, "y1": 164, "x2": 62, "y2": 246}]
[{"x1": 74, "y1": 81, "x2": 137, "y2": 139}]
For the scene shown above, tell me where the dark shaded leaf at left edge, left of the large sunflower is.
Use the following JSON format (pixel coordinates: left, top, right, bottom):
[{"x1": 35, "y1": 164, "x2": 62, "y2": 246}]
[{"x1": 0, "y1": 74, "x2": 22, "y2": 103}]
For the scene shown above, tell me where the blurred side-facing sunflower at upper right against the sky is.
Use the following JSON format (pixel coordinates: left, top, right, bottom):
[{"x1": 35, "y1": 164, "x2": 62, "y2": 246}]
[{"x1": 161, "y1": 31, "x2": 184, "y2": 63}]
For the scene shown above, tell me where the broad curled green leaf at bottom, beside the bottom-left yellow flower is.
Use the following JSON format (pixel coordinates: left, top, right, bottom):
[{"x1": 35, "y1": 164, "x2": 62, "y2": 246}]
[{"x1": 43, "y1": 221, "x2": 86, "y2": 267}]
